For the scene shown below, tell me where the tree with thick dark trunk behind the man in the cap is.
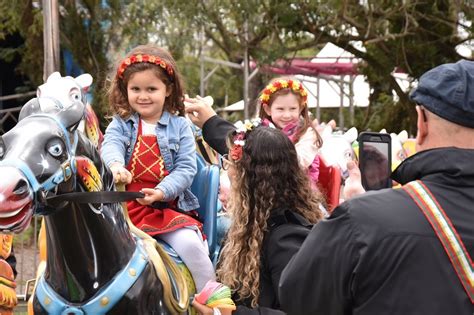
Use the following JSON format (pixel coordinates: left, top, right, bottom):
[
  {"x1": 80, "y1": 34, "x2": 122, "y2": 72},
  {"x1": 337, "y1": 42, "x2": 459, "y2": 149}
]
[{"x1": 286, "y1": 0, "x2": 474, "y2": 132}]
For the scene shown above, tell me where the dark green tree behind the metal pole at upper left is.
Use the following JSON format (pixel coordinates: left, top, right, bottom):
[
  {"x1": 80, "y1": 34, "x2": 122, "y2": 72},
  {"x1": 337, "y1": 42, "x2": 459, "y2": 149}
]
[{"x1": 0, "y1": 0, "x2": 169, "y2": 126}]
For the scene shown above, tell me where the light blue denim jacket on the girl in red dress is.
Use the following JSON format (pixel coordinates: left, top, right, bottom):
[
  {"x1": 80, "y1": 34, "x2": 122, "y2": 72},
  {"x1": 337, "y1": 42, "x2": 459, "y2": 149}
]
[{"x1": 101, "y1": 111, "x2": 199, "y2": 211}]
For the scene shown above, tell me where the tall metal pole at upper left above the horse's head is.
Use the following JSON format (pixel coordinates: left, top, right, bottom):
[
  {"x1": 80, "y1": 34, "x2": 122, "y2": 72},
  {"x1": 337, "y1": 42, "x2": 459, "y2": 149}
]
[{"x1": 43, "y1": 0, "x2": 59, "y2": 81}]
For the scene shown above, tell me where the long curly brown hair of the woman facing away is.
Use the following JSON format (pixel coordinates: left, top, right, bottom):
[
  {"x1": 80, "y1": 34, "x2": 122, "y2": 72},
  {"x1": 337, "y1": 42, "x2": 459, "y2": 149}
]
[{"x1": 217, "y1": 127, "x2": 324, "y2": 307}]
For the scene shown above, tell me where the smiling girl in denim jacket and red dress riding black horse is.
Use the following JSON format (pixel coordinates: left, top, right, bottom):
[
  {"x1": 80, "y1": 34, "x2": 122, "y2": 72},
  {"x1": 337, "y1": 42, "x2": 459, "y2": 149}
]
[{"x1": 101, "y1": 45, "x2": 215, "y2": 290}]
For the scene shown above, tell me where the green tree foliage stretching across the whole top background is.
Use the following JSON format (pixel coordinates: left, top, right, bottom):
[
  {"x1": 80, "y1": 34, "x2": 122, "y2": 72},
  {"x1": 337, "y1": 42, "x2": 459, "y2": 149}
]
[{"x1": 0, "y1": 0, "x2": 474, "y2": 130}]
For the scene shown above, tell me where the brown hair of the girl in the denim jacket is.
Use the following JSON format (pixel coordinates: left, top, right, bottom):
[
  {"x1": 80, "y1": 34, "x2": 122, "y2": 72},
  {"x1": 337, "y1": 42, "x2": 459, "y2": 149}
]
[{"x1": 109, "y1": 44, "x2": 184, "y2": 118}]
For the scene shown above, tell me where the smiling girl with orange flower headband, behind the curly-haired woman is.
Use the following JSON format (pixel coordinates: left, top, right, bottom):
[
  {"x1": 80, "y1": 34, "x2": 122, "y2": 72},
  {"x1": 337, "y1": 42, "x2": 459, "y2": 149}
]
[{"x1": 258, "y1": 77, "x2": 323, "y2": 187}]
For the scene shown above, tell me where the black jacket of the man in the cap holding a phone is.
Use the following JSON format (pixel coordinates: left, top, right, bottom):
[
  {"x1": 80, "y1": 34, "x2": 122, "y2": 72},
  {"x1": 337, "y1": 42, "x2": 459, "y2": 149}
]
[{"x1": 279, "y1": 148, "x2": 474, "y2": 315}]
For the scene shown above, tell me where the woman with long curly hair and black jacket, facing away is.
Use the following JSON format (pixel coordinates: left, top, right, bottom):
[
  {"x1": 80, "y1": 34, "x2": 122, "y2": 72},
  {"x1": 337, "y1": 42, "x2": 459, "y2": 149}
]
[{"x1": 193, "y1": 122, "x2": 323, "y2": 314}]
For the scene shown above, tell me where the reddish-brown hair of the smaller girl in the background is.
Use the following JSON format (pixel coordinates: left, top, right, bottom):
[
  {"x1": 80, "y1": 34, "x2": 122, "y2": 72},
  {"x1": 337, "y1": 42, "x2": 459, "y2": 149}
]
[{"x1": 259, "y1": 77, "x2": 323, "y2": 148}]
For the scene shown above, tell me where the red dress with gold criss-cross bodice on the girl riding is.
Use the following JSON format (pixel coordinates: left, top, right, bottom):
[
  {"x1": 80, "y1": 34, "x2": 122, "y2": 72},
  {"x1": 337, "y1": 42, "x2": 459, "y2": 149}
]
[{"x1": 126, "y1": 121, "x2": 202, "y2": 236}]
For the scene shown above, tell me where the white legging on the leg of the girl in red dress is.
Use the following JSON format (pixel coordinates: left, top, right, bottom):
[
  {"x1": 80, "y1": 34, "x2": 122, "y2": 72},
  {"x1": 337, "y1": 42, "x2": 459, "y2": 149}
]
[{"x1": 157, "y1": 227, "x2": 216, "y2": 292}]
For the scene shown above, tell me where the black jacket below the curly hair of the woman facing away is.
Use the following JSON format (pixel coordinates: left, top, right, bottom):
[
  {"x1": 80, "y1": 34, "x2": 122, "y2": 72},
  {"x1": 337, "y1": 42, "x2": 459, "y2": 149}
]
[{"x1": 232, "y1": 209, "x2": 311, "y2": 315}]
